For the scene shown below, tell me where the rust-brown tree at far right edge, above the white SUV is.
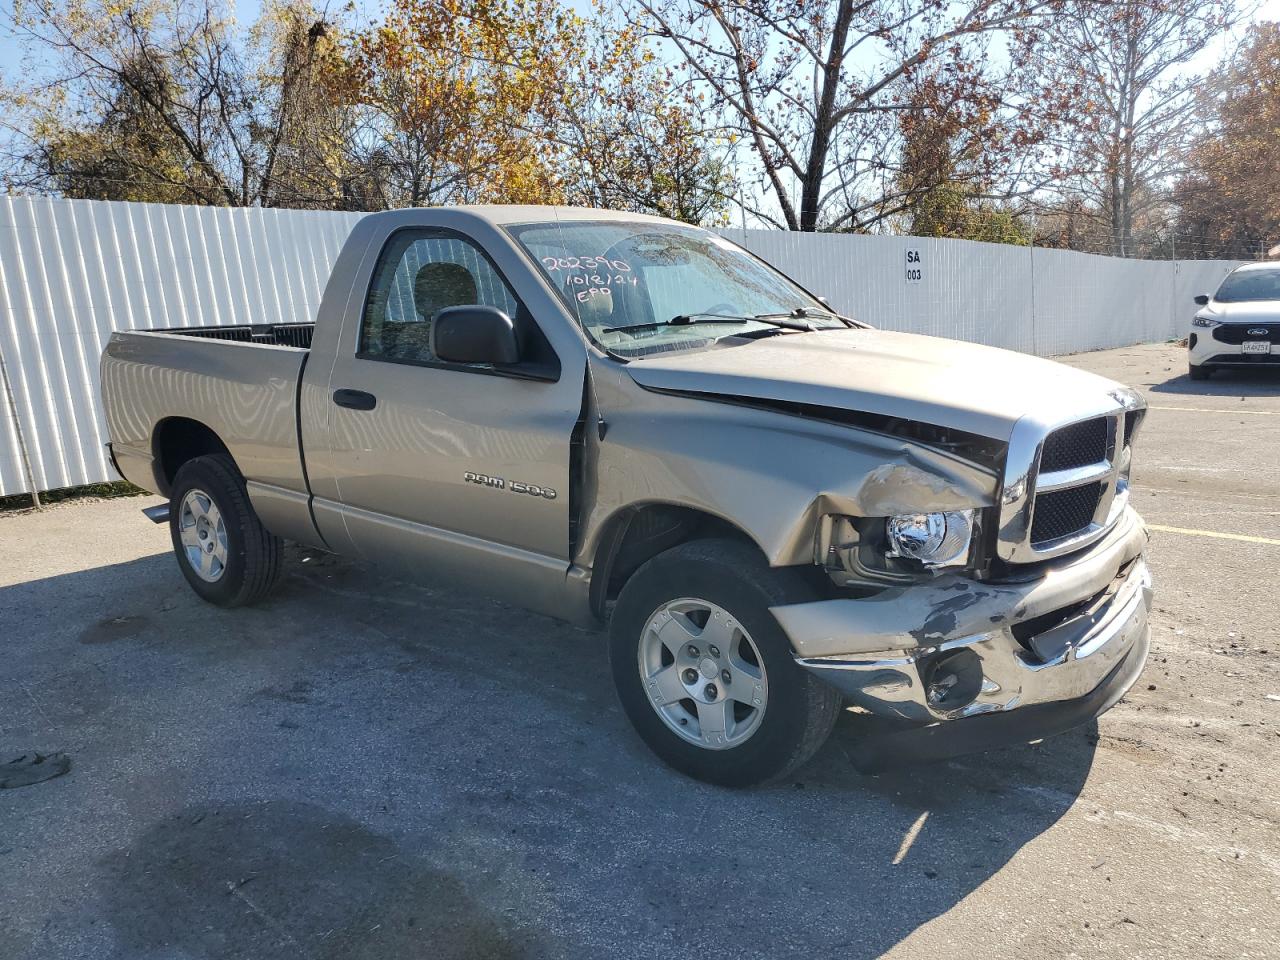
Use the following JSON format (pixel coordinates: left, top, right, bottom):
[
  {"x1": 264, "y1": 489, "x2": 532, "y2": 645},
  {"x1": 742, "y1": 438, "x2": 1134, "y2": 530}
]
[{"x1": 1175, "y1": 23, "x2": 1280, "y2": 259}]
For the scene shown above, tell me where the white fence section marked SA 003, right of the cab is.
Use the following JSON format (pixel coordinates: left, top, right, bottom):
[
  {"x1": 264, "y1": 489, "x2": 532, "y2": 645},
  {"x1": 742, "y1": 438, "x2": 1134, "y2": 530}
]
[{"x1": 722, "y1": 230, "x2": 1236, "y2": 356}]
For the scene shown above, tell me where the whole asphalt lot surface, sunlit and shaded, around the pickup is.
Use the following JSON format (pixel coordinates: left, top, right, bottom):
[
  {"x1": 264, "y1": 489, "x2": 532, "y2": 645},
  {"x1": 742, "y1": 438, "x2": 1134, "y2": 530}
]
[{"x1": 0, "y1": 346, "x2": 1280, "y2": 960}]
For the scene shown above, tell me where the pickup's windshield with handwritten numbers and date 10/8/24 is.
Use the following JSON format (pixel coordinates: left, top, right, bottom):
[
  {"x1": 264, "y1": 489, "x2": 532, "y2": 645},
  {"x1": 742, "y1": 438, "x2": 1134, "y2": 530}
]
[{"x1": 508, "y1": 220, "x2": 845, "y2": 358}]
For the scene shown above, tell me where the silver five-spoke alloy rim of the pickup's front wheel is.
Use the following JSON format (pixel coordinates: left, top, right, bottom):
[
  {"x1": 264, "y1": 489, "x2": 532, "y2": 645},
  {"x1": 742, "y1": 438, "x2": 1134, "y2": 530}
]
[{"x1": 639, "y1": 598, "x2": 769, "y2": 750}]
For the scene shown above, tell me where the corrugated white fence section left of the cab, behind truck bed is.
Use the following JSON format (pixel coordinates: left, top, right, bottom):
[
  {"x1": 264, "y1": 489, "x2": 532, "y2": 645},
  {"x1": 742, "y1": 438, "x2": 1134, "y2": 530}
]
[{"x1": 0, "y1": 197, "x2": 360, "y2": 495}]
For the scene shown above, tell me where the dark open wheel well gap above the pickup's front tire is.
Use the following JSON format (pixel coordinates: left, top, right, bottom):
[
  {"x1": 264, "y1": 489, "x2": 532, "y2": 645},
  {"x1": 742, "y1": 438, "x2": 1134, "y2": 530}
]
[{"x1": 591, "y1": 503, "x2": 759, "y2": 620}]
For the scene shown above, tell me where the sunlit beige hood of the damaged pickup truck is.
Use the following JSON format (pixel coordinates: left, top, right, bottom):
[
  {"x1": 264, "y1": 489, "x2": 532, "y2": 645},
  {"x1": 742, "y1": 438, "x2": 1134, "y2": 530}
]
[{"x1": 627, "y1": 329, "x2": 1120, "y2": 442}]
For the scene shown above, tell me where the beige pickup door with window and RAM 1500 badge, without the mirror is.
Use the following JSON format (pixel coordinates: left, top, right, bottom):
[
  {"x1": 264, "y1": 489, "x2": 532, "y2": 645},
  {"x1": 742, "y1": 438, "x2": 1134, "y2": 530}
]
[{"x1": 308, "y1": 221, "x2": 585, "y2": 612}]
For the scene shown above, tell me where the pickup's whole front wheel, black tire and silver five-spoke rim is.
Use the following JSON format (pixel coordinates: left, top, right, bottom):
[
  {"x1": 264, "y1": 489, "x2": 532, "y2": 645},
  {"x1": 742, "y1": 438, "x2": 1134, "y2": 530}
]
[{"x1": 609, "y1": 540, "x2": 842, "y2": 786}]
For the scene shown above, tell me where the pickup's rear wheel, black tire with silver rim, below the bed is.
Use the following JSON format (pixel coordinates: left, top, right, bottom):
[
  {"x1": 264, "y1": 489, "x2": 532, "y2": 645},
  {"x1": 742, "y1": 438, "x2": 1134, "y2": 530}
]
[{"x1": 169, "y1": 454, "x2": 283, "y2": 607}]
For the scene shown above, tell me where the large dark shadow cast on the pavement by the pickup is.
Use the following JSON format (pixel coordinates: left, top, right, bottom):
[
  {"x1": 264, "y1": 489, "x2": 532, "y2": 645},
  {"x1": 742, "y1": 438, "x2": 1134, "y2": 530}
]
[{"x1": 0, "y1": 550, "x2": 1097, "y2": 960}]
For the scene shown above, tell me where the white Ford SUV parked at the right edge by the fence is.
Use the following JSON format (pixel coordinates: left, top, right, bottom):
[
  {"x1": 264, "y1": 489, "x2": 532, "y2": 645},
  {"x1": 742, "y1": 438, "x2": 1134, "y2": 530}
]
[{"x1": 1187, "y1": 261, "x2": 1280, "y2": 380}]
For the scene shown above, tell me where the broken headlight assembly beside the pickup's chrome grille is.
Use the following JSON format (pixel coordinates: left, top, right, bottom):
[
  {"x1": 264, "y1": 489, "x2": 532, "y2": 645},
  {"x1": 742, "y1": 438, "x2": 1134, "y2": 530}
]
[{"x1": 818, "y1": 509, "x2": 982, "y2": 586}]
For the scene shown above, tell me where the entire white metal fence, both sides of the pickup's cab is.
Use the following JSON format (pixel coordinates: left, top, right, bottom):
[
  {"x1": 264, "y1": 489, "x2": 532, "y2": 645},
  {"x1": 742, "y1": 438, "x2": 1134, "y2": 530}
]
[{"x1": 0, "y1": 197, "x2": 1249, "y2": 495}]
